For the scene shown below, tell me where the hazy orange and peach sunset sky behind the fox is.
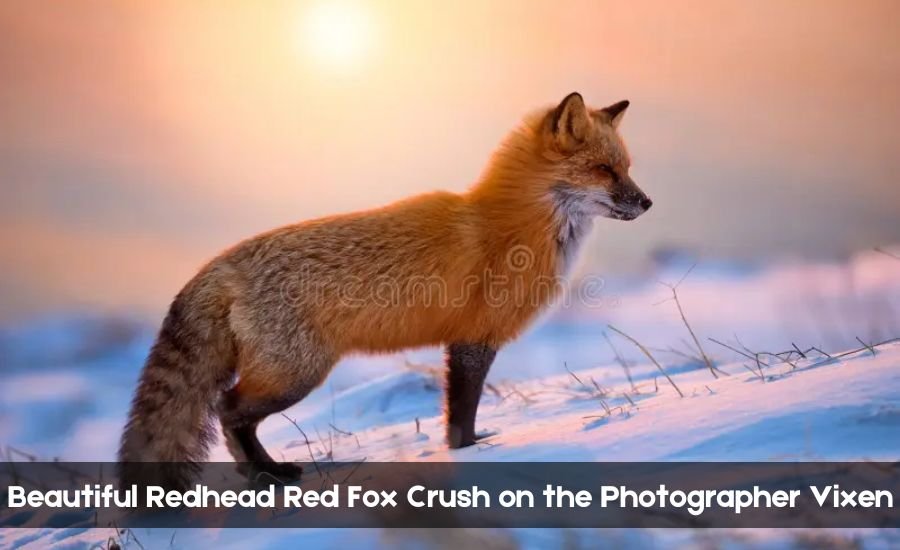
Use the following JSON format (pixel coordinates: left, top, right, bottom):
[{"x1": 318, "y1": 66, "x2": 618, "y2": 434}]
[{"x1": 0, "y1": 0, "x2": 900, "y2": 320}]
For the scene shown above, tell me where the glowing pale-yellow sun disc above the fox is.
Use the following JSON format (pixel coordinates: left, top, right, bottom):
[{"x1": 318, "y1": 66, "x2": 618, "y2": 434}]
[{"x1": 300, "y1": 0, "x2": 375, "y2": 70}]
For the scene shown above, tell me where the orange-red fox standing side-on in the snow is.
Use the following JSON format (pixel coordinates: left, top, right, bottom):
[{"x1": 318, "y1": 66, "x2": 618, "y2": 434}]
[{"x1": 119, "y1": 93, "x2": 652, "y2": 487}]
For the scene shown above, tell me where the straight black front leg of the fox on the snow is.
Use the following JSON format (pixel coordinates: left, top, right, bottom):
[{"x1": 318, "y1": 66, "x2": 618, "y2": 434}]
[{"x1": 446, "y1": 344, "x2": 497, "y2": 449}]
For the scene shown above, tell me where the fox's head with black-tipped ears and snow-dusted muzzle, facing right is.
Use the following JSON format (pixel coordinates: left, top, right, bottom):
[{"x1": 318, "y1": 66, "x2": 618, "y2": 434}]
[{"x1": 540, "y1": 93, "x2": 653, "y2": 220}]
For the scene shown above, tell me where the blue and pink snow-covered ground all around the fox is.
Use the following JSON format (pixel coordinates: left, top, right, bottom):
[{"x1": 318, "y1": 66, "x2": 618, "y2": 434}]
[{"x1": 0, "y1": 251, "x2": 900, "y2": 548}]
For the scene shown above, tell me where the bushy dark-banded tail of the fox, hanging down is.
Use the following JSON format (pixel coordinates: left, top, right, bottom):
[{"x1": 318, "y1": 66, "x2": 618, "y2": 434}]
[{"x1": 118, "y1": 285, "x2": 234, "y2": 489}]
